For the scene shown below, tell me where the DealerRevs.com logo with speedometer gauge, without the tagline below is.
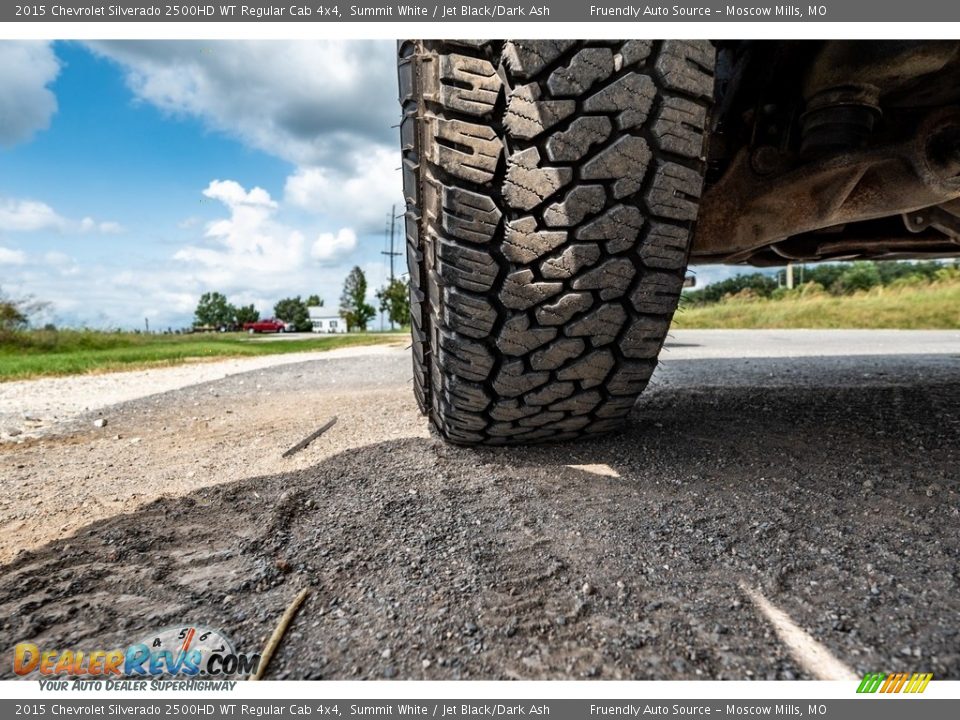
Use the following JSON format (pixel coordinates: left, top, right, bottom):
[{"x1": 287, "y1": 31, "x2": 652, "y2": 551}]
[{"x1": 13, "y1": 625, "x2": 260, "y2": 678}]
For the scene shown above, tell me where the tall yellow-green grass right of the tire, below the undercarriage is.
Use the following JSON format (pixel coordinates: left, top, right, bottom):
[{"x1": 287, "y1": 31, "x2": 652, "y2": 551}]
[{"x1": 674, "y1": 281, "x2": 960, "y2": 330}]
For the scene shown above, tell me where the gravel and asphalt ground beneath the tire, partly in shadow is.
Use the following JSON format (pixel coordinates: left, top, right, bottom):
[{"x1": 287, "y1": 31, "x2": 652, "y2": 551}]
[{"x1": 0, "y1": 331, "x2": 960, "y2": 679}]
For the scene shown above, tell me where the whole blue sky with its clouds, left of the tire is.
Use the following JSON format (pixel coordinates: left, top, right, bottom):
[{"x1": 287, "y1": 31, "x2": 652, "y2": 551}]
[{"x1": 0, "y1": 41, "x2": 402, "y2": 328}]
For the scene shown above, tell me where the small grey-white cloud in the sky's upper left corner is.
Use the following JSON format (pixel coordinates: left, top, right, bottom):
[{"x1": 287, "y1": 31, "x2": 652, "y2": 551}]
[{"x1": 0, "y1": 41, "x2": 60, "y2": 147}]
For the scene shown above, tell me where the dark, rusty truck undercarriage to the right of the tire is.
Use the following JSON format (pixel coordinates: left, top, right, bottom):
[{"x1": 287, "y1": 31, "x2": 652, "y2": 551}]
[{"x1": 690, "y1": 41, "x2": 960, "y2": 266}]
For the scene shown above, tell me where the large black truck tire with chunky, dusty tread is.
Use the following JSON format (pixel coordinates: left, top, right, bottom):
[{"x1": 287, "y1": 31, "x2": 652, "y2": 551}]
[{"x1": 398, "y1": 40, "x2": 715, "y2": 445}]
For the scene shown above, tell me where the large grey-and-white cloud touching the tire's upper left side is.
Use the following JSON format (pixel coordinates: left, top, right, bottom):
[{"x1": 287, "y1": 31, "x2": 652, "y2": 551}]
[{"x1": 80, "y1": 40, "x2": 403, "y2": 232}]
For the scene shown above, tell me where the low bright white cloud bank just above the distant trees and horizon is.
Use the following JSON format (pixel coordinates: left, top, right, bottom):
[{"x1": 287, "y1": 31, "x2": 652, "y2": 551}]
[{"x1": 7, "y1": 180, "x2": 372, "y2": 328}]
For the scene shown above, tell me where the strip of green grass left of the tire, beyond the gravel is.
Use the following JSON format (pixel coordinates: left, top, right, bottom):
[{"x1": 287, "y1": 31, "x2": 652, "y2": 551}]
[{"x1": 0, "y1": 330, "x2": 409, "y2": 382}]
